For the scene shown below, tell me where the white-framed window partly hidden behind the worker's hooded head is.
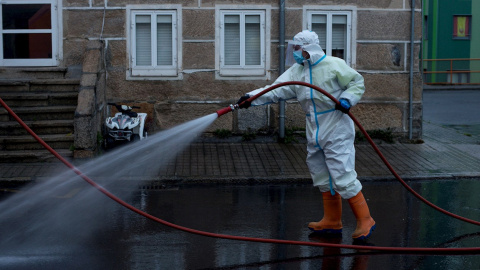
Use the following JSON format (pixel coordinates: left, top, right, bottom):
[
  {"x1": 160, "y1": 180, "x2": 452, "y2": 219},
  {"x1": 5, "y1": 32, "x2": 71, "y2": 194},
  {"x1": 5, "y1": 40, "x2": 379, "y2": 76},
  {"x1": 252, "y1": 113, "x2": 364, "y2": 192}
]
[{"x1": 307, "y1": 11, "x2": 352, "y2": 64}]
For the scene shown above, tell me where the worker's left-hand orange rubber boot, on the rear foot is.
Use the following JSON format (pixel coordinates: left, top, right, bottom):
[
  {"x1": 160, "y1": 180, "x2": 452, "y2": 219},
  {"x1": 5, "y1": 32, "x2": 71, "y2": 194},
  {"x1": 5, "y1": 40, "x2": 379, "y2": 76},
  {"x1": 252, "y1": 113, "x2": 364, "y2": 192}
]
[{"x1": 308, "y1": 192, "x2": 342, "y2": 233}]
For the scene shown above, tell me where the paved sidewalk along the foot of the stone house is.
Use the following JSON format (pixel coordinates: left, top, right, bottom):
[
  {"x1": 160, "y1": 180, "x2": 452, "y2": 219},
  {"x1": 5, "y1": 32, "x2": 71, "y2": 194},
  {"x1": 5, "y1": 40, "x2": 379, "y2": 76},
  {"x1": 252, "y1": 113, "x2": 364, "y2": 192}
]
[{"x1": 0, "y1": 122, "x2": 480, "y2": 186}]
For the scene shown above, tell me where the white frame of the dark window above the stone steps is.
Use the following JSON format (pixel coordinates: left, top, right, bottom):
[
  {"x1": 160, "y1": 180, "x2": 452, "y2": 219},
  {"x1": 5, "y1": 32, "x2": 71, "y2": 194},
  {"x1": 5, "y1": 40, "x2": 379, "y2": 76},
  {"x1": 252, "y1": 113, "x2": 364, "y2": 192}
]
[{"x1": 0, "y1": 0, "x2": 63, "y2": 67}]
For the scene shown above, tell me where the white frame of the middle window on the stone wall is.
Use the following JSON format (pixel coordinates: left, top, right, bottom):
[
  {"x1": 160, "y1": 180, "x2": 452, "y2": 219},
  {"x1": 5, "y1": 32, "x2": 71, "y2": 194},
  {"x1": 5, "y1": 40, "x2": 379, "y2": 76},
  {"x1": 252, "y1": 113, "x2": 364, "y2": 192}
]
[{"x1": 215, "y1": 5, "x2": 271, "y2": 80}]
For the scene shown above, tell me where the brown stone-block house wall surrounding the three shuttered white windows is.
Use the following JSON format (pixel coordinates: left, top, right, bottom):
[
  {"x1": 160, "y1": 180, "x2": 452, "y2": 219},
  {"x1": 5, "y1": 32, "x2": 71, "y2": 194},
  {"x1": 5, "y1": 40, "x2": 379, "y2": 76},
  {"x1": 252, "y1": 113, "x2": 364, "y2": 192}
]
[{"x1": 63, "y1": 0, "x2": 422, "y2": 137}]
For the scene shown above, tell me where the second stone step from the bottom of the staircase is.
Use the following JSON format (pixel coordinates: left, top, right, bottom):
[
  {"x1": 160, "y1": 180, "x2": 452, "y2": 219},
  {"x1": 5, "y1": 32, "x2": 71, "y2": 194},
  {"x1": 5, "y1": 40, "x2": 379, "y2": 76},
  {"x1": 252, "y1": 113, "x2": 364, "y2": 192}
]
[{"x1": 0, "y1": 134, "x2": 74, "y2": 151}]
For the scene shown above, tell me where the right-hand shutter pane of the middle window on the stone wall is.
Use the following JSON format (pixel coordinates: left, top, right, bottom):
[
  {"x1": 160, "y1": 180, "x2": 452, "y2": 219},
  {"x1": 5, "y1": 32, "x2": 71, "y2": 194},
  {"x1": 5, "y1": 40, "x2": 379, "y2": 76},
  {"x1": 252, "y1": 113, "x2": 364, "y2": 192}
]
[{"x1": 245, "y1": 15, "x2": 261, "y2": 65}]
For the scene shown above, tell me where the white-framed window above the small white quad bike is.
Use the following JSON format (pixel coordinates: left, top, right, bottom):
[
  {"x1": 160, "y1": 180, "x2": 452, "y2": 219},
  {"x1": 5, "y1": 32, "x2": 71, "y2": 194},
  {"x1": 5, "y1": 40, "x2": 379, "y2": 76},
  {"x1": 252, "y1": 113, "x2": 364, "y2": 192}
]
[{"x1": 129, "y1": 9, "x2": 179, "y2": 77}]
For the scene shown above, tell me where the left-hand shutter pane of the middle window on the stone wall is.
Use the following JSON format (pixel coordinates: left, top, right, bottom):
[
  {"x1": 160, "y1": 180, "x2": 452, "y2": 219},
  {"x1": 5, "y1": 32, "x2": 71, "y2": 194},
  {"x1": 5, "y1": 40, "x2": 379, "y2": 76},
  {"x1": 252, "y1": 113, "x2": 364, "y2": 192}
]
[{"x1": 224, "y1": 15, "x2": 240, "y2": 65}]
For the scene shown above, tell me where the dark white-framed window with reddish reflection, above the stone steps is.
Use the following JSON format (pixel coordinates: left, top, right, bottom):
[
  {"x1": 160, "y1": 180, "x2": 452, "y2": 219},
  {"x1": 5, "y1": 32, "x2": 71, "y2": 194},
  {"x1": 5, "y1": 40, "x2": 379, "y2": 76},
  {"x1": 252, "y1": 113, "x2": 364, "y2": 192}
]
[{"x1": 0, "y1": 0, "x2": 59, "y2": 66}]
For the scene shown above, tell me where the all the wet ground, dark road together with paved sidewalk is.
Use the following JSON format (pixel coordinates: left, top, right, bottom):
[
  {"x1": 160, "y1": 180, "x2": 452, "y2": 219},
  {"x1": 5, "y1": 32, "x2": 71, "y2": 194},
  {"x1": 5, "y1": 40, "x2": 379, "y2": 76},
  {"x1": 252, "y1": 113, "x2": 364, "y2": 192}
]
[{"x1": 0, "y1": 89, "x2": 480, "y2": 269}]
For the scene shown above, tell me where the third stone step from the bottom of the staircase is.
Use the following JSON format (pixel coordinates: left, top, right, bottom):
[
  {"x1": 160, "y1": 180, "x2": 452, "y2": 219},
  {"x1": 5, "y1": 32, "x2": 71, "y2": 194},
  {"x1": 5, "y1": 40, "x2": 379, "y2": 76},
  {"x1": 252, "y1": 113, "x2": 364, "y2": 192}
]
[{"x1": 0, "y1": 117, "x2": 74, "y2": 136}]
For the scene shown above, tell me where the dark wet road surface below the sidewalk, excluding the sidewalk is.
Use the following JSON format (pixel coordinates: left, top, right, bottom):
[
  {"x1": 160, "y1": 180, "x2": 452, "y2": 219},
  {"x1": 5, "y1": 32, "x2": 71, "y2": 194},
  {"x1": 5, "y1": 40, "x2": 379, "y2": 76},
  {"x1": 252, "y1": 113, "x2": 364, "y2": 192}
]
[{"x1": 0, "y1": 179, "x2": 480, "y2": 269}]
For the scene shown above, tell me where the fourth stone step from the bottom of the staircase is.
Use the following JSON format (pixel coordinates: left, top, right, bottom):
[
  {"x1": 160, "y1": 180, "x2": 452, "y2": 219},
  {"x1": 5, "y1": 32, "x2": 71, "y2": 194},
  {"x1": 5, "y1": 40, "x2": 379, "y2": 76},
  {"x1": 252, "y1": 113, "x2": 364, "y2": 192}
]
[{"x1": 0, "y1": 104, "x2": 76, "y2": 121}]
